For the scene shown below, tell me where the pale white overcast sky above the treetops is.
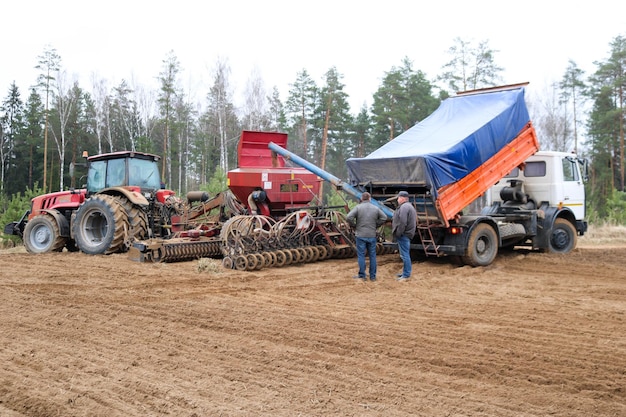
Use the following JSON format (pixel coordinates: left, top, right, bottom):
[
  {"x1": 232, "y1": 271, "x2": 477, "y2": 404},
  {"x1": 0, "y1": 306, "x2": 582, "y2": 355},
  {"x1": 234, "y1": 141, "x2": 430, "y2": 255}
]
[{"x1": 0, "y1": 0, "x2": 626, "y2": 113}]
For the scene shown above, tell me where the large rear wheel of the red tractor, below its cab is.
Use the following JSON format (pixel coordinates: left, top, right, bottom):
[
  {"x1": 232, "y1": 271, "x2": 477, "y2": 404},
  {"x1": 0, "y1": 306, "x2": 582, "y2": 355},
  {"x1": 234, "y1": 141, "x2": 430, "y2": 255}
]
[{"x1": 72, "y1": 194, "x2": 129, "y2": 255}]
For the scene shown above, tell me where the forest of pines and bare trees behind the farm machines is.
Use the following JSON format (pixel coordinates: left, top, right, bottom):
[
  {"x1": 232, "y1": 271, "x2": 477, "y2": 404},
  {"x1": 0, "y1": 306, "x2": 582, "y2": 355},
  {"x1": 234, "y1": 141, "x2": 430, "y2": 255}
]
[{"x1": 0, "y1": 36, "x2": 626, "y2": 231}]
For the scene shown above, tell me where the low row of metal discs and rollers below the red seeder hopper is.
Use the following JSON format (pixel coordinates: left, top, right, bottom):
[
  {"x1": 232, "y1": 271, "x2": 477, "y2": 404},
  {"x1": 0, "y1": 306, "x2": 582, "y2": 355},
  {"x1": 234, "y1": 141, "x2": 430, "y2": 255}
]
[{"x1": 129, "y1": 211, "x2": 391, "y2": 271}]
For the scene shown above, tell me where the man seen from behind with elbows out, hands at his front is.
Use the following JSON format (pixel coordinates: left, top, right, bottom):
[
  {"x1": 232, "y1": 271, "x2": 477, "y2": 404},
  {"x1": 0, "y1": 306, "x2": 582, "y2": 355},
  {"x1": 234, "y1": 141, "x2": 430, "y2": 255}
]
[{"x1": 347, "y1": 192, "x2": 387, "y2": 281}]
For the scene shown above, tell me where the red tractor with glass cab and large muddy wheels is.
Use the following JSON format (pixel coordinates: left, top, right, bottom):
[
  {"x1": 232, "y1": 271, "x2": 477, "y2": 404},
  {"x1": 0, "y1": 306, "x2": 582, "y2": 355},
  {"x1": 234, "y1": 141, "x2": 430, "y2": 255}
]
[{"x1": 4, "y1": 151, "x2": 185, "y2": 255}]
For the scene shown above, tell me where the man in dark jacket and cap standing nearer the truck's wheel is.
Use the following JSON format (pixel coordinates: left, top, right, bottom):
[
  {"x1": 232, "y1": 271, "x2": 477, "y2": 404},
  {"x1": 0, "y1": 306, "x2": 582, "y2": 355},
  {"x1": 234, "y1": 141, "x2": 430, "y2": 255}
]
[{"x1": 391, "y1": 191, "x2": 417, "y2": 281}]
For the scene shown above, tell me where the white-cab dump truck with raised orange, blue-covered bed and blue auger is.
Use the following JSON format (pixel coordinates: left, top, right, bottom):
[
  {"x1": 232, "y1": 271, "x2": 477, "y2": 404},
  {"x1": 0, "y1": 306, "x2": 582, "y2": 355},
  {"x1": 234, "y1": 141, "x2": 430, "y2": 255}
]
[{"x1": 272, "y1": 83, "x2": 587, "y2": 266}]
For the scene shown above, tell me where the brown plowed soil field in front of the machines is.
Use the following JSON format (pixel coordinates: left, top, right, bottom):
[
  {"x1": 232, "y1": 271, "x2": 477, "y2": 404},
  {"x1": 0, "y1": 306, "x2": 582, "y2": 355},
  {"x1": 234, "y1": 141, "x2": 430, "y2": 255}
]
[{"x1": 0, "y1": 239, "x2": 626, "y2": 417}]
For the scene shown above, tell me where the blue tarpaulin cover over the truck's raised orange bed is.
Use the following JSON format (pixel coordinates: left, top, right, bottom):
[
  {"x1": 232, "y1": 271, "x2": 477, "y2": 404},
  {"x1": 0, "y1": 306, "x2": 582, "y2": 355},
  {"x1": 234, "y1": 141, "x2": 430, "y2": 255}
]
[{"x1": 346, "y1": 87, "x2": 530, "y2": 195}]
